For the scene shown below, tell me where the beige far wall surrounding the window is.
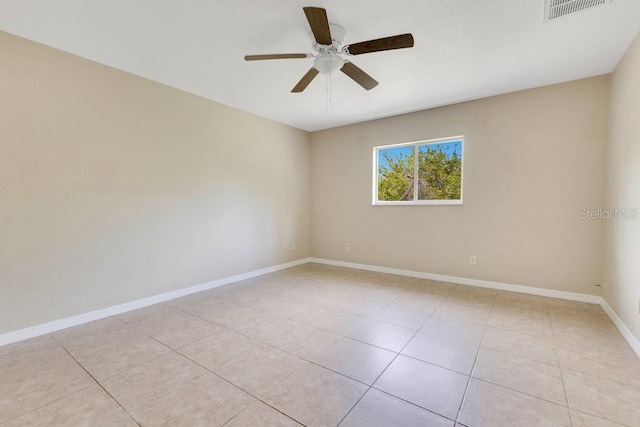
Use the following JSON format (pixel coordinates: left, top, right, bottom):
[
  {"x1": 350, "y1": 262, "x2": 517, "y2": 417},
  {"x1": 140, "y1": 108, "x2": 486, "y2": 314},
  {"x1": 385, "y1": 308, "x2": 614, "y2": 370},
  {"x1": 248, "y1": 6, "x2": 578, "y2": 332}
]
[{"x1": 311, "y1": 76, "x2": 609, "y2": 293}]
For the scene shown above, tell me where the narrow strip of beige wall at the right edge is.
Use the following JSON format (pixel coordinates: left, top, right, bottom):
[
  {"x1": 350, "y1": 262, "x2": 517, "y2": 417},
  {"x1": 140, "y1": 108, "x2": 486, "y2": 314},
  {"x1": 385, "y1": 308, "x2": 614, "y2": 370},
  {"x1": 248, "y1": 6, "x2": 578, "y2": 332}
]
[{"x1": 603, "y1": 31, "x2": 640, "y2": 340}]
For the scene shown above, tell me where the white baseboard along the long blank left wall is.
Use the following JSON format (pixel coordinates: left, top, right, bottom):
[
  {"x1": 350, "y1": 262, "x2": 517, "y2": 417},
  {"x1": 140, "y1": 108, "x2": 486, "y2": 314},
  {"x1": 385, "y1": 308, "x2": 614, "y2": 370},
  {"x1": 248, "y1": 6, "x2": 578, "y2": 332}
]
[{"x1": 0, "y1": 258, "x2": 309, "y2": 346}]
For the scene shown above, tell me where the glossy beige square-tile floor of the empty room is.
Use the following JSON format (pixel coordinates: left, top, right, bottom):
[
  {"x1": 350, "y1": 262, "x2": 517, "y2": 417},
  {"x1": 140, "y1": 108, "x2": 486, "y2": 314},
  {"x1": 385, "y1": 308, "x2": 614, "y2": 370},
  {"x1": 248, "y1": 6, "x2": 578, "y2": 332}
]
[{"x1": 0, "y1": 264, "x2": 640, "y2": 427}]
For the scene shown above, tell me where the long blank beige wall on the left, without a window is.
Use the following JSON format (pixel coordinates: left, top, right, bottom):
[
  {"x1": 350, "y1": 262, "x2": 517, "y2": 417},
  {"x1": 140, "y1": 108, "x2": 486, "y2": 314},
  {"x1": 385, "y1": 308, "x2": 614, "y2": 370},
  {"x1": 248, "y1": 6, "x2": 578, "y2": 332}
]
[{"x1": 0, "y1": 32, "x2": 309, "y2": 333}]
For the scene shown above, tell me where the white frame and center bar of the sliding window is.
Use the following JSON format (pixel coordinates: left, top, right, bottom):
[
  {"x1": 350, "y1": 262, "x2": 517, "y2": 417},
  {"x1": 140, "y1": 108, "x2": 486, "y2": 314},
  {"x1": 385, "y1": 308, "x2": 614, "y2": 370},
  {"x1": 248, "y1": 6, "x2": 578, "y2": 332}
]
[{"x1": 372, "y1": 135, "x2": 465, "y2": 206}]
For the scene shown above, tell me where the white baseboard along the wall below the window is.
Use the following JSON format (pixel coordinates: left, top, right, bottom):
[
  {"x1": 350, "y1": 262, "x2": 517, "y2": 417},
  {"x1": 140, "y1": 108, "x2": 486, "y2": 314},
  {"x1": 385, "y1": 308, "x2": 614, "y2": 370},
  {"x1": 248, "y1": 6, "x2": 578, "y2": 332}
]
[{"x1": 310, "y1": 258, "x2": 601, "y2": 304}]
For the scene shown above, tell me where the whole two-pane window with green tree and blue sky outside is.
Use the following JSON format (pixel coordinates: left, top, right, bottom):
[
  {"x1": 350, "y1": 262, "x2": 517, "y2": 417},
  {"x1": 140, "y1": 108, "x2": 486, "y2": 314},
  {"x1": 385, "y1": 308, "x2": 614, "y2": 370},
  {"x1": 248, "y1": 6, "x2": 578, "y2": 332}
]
[{"x1": 373, "y1": 136, "x2": 463, "y2": 205}]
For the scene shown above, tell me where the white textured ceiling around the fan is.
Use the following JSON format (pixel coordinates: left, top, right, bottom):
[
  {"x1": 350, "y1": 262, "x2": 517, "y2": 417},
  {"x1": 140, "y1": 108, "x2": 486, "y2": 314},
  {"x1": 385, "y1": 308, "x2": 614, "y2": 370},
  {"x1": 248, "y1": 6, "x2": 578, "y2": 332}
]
[{"x1": 0, "y1": 0, "x2": 640, "y2": 131}]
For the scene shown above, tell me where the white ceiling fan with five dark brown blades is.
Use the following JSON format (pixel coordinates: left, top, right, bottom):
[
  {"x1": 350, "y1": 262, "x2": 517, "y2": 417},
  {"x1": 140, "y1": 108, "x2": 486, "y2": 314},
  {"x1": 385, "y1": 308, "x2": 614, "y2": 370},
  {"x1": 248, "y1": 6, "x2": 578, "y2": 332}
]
[{"x1": 244, "y1": 7, "x2": 413, "y2": 93}]
